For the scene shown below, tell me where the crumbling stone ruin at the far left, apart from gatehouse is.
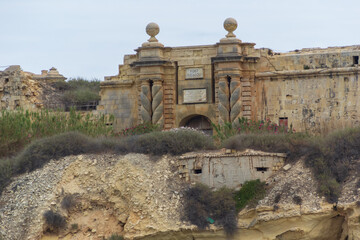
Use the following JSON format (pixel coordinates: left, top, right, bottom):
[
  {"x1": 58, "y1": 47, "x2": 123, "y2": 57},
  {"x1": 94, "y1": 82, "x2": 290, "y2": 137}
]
[{"x1": 0, "y1": 65, "x2": 66, "y2": 110}]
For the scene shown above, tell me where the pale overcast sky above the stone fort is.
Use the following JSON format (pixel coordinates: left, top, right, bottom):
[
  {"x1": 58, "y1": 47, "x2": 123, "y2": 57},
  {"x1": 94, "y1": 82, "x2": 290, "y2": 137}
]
[{"x1": 0, "y1": 0, "x2": 360, "y2": 80}]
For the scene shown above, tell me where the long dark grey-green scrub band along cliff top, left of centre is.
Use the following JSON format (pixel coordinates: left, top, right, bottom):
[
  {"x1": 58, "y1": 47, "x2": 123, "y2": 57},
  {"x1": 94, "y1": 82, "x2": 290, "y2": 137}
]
[{"x1": 0, "y1": 130, "x2": 214, "y2": 195}]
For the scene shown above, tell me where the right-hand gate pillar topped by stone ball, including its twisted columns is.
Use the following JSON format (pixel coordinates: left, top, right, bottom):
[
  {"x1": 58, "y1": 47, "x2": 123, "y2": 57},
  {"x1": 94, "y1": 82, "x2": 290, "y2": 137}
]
[{"x1": 211, "y1": 18, "x2": 260, "y2": 125}]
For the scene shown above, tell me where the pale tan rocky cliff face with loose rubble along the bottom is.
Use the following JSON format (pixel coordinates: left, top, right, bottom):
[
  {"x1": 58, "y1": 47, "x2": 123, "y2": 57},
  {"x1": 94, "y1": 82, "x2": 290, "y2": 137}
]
[{"x1": 0, "y1": 154, "x2": 360, "y2": 240}]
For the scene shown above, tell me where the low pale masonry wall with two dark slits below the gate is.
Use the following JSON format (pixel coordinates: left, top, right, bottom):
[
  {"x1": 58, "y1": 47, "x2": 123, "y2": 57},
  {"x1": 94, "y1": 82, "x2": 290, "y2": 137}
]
[{"x1": 178, "y1": 149, "x2": 286, "y2": 189}]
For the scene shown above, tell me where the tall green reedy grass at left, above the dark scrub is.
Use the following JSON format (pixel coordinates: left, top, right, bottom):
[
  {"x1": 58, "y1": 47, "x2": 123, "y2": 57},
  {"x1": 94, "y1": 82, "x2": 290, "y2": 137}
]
[{"x1": 0, "y1": 109, "x2": 112, "y2": 158}]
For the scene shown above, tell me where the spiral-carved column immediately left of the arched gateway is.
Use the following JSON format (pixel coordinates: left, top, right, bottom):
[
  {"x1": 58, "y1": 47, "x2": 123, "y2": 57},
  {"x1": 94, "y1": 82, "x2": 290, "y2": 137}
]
[{"x1": 152, "y1": 80, "x2": 164, "y2": 128}]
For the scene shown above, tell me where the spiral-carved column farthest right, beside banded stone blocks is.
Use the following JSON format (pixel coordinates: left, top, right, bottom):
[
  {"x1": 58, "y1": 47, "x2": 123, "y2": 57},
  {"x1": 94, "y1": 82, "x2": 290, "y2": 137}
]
[{"x1": 230, "y1": 77, "x2": 241, "y2": 125}]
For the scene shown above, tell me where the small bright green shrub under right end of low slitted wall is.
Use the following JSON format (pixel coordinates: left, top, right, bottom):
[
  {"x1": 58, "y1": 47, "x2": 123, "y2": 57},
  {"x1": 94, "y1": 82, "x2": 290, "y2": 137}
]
[{"x1": 234, "y1": 179, "x2": 268, "y2": 211}]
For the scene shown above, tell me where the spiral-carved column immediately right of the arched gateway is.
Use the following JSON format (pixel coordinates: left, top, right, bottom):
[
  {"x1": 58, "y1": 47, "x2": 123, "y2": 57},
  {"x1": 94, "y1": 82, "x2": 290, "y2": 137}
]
[{"x1": 218, "y1": 77, "x2": 230, "y2": 125}]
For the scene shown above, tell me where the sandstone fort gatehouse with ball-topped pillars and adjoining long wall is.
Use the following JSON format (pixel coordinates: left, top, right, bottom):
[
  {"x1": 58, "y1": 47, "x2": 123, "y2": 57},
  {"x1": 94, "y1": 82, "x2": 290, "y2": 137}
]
[{"x1": 98, "y1": 18, "x2": 360, "y2": 133}]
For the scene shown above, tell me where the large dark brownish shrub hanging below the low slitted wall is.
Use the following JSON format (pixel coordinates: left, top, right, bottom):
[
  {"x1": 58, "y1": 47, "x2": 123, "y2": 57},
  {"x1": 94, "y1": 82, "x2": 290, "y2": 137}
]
[{"x1": 183, "y1": 184, "x2": 237, "y2": 235}]
